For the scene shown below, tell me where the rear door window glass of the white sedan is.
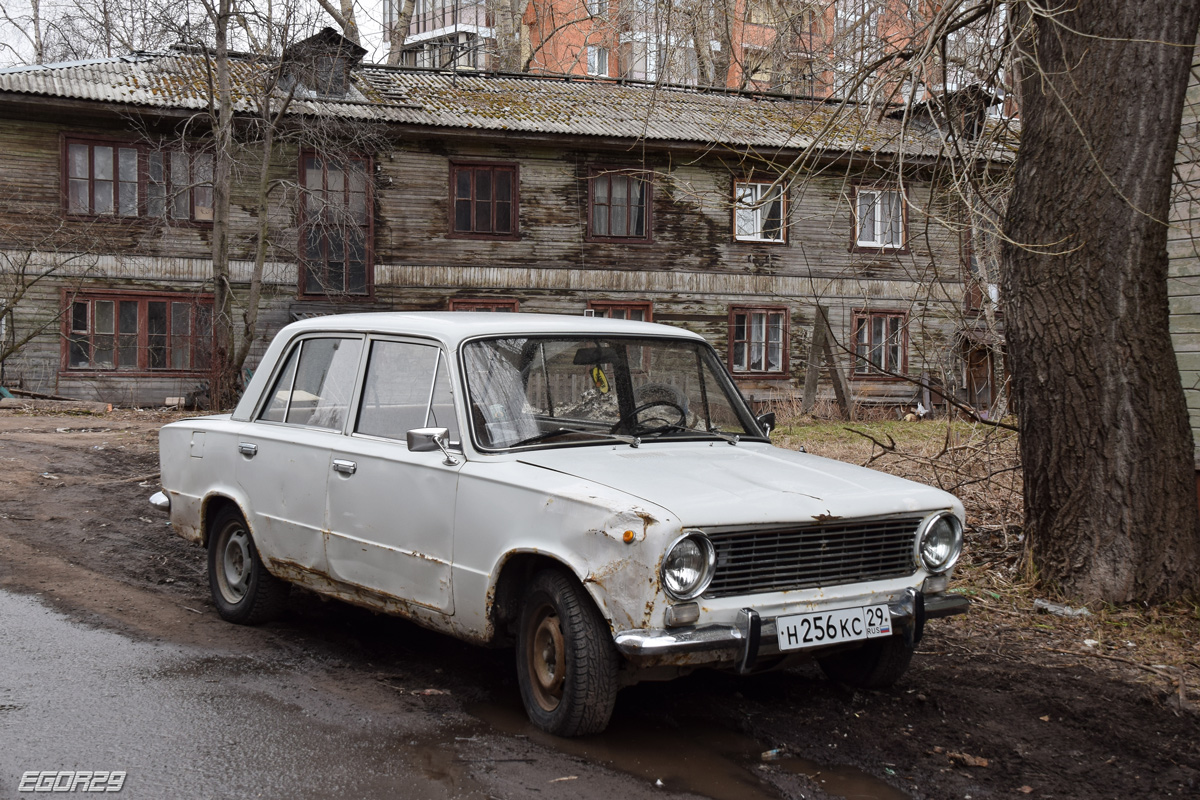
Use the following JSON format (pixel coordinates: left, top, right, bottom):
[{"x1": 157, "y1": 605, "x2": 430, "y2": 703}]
[{"x1": 258, "y1": 337, "x2": 362, "y2": 431}]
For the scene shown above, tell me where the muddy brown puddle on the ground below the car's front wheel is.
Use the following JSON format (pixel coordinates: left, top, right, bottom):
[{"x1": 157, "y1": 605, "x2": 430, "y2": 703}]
[{"x1": 467, "y1": 703, "x2": 911, "y2": 800}]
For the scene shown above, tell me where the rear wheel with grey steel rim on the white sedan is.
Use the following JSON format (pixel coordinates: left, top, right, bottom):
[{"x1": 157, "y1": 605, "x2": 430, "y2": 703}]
[{"x1": 209, "y1": 506, "x2": 288, "y2": 625}]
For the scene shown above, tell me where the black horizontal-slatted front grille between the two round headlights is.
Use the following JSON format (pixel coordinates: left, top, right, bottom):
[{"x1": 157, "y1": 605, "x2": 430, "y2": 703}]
[{"x1": 704, "y1": 516, "x2": 924, "y2": 597}]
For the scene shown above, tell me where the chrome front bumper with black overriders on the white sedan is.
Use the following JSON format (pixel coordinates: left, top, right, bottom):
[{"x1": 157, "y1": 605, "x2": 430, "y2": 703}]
[{"x1": 613, "y1": 589, "x2": 971, "y2": 673}]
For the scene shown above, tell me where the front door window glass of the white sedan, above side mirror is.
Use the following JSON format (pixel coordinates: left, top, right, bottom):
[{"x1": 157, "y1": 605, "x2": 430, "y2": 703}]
[{"x1": 354, "y1": 342, "x2": 458, "y2": 440}]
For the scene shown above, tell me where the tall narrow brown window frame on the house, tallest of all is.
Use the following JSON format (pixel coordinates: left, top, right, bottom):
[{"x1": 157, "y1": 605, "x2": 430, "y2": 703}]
[{"x1": 296, "y1": 150, "x2": 374, "y2": 301}]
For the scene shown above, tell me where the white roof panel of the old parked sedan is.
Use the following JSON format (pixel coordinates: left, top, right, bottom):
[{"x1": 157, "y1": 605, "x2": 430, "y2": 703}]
[{"x1": 281, "y1": 311, "x2": 704, "y2": 348}]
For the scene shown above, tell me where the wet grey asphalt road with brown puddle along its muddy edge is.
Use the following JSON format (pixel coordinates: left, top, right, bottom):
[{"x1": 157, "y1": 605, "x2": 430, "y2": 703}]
[{"x1": 0, "y1": 582, "x2": 905, "y2": 800}]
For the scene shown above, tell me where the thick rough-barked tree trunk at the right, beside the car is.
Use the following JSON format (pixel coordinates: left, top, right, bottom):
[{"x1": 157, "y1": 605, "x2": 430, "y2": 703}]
[{"x1": 1003, "y1": 0, "x2": 1200, "y2": 602}]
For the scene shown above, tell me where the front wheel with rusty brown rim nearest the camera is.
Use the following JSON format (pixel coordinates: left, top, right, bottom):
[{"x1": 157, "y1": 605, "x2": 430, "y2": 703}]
[{"x1": 517, "y1": 570, "x2": 619, "y2": 736}]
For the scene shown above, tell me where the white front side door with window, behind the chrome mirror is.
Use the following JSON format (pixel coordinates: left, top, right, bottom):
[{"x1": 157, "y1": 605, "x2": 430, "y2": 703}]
[{"x1": 325, "y1": 339, "x2": 463, "y2": 614}]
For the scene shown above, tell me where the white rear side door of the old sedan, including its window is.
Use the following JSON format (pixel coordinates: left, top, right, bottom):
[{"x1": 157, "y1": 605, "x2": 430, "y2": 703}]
[{"x1": 236, "y1": 335, "x2": 362, "y2": 572}]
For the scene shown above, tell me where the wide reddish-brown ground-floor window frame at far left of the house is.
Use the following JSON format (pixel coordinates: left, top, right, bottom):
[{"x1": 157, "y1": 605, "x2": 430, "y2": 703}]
[{"x1": 59, "y1": 289, "x2": 215, "y2": 378}]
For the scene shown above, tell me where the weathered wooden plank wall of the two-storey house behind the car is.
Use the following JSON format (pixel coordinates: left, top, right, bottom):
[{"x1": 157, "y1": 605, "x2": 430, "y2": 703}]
[{"x1": 0, "y1": 112, "x2": 962, "y2": 403}]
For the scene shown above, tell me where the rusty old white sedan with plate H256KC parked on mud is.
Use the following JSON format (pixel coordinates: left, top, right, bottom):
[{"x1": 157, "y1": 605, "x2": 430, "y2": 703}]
[{"x1": 151, "y1": 313, "x2": 967, "y2": 736}]
